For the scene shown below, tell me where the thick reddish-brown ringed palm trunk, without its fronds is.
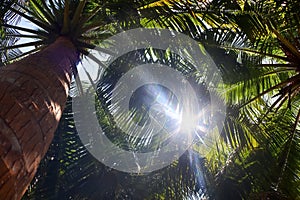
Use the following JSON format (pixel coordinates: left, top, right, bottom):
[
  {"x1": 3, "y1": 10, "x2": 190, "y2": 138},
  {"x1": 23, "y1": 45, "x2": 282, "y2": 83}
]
[{"x1": 0, "y1": 37, "x2": 79, "y2": 199}]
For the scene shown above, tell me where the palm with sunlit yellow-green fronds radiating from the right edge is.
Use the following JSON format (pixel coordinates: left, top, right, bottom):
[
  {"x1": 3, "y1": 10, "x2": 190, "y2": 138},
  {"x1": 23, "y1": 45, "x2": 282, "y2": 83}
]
[{"x1": 195, "y1": 1, "x2": 300, "y2": 199}]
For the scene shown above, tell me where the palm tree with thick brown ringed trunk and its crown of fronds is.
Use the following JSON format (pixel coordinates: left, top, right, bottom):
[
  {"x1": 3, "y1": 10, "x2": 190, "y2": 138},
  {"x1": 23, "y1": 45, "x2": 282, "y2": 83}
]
[{"x1": 0, "y1": 0, "x2": 229, "y2": 199}]
